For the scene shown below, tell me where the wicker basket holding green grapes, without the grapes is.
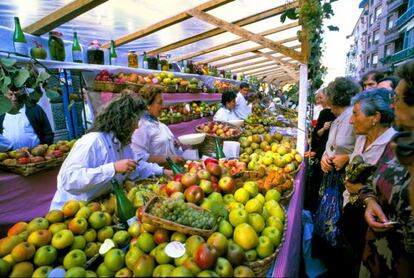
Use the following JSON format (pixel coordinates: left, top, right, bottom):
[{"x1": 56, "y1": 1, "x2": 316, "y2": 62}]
[{"x1": 142, "y1": 196, "x2": 217, "y2": 237}]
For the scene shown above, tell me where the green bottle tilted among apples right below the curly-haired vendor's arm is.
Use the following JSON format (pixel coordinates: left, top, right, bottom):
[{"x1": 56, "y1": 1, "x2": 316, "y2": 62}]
[{"x1": 111, "y1": 179, "x2": 137, "y2": 227}]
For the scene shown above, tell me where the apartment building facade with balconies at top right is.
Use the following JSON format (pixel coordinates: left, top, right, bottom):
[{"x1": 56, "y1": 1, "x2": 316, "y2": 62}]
[{"x1": 346, "y1": 0, "x2": 408, "y2": 79}]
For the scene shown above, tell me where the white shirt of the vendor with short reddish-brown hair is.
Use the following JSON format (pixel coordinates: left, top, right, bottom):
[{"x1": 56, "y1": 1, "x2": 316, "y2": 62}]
[{"x1": 131, "y1": 114, "x2": 179, "y2": 160}]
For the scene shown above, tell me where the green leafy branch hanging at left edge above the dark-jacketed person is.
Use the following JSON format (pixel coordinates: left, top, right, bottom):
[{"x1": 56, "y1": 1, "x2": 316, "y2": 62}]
[{"x1": 0, "y1": 54, "x2": 59, "y2": 114}]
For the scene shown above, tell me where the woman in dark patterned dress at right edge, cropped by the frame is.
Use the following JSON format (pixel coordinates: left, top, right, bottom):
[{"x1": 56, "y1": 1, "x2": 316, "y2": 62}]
[{"x1": 359, "y1": 62, "x2": 414, "y2": 277}]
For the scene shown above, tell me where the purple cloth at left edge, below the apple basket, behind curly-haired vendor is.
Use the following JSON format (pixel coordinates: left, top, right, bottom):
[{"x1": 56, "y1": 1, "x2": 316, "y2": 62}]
[{"x1": 0, "y1": 167, "x2": 60, "y2": 225}]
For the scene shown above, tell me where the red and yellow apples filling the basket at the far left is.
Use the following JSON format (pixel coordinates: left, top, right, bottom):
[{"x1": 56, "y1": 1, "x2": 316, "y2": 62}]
[{"x1": 0, "y1": 140, "x2": 76, "y2": 166}]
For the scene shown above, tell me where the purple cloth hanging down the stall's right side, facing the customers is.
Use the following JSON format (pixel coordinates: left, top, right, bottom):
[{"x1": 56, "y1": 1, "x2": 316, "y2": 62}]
[{"x1": 268, "y1": 164, "x2": 306, "y2": 277}]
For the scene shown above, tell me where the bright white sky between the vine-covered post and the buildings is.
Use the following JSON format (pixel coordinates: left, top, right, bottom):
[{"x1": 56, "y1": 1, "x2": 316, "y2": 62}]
[{"x1": 322, "y1": 0, "x2": 362, "y2": 85}]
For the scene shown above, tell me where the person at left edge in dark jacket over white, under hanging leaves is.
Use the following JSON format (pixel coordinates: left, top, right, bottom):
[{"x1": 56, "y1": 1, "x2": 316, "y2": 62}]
[{"x1": 0, "y1": 88, "x2": 54, "y2": 150}]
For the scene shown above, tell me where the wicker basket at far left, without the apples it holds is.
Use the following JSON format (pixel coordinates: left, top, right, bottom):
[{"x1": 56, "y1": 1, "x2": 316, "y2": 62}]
[{"x1": 0, "y1": 154, "x2": 67, "y2": 177}]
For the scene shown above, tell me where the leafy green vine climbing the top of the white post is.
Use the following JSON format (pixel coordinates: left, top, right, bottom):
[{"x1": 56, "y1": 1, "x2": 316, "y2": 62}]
[{"x1": 280, "y1": 0, "x2": 339, "y2": 101}]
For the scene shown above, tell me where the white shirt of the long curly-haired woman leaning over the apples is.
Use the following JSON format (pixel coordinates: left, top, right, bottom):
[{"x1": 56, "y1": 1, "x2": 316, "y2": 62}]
[{"x1": 50, "y1": 132, "x2": 163, "y2": 210}]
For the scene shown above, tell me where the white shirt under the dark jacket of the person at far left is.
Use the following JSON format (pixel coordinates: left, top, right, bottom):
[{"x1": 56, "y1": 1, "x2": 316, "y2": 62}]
[{"x1": 3, "y1": 105, "x2": 40, "y2": 150}]
